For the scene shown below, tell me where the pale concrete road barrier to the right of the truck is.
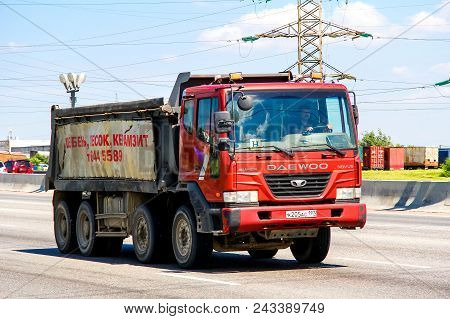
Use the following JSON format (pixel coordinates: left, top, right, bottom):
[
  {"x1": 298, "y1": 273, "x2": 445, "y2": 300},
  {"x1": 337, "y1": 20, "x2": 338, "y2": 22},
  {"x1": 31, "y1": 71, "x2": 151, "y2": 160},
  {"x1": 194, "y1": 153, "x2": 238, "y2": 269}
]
[{"x1": 362, "y1": 180, "x2": 450, "y2": 212}]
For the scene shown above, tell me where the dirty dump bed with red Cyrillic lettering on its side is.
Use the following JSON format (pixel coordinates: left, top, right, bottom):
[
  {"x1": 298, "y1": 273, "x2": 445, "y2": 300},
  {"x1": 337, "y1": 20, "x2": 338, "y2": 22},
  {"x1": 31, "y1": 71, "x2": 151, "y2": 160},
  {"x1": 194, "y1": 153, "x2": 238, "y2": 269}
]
[{"x1": 46, "y1": 98, "x2": 176, "y2": 193}]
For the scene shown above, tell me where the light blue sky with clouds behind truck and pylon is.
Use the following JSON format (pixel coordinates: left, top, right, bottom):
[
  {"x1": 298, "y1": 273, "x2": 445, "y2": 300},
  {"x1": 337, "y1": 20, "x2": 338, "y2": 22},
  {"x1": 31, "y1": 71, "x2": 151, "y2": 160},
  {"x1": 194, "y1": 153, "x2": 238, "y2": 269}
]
[{"x1": 0, "y1": 0, "x2": 450, "y2": 146}]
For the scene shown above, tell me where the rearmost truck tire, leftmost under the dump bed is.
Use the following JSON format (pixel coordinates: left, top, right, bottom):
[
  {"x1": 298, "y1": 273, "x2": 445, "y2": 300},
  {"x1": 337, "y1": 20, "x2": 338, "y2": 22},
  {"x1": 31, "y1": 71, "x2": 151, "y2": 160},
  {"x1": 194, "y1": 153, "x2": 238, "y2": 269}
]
[{"x1": 53, "y1": 201, "x2": 78, "y2": 254}]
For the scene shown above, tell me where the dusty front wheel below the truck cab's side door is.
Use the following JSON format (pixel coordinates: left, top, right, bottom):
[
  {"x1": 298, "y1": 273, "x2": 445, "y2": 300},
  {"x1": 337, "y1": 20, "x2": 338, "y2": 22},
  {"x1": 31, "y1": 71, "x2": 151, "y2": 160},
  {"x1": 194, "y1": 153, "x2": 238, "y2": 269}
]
[{"x1": 172, "y1": 206, "x2": 213, "y2": 268}]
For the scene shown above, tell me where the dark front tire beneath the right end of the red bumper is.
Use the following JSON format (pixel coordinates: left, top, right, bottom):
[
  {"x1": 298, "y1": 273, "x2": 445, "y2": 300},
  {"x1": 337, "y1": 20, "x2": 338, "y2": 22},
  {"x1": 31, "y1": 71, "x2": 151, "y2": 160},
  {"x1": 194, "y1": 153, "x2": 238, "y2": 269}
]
[{"x1": 291, "y1": 227, "x2": 331, "y2": 263}]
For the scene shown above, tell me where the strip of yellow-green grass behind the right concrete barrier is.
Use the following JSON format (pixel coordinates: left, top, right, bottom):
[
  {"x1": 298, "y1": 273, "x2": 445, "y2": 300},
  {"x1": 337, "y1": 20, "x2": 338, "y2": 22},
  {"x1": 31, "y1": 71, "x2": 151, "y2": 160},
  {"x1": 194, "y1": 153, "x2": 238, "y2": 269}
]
[{"x1": 363, "y1": 169, "x2": 450, "y2": 182}]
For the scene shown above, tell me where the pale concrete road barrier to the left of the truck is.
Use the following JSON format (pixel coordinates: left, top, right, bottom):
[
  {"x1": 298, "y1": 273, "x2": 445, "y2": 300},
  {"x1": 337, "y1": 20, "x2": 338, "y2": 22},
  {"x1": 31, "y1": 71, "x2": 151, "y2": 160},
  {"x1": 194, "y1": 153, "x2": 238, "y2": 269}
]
[{"x1": 0, "y1": 174, "x2": 45, "y2": 193}]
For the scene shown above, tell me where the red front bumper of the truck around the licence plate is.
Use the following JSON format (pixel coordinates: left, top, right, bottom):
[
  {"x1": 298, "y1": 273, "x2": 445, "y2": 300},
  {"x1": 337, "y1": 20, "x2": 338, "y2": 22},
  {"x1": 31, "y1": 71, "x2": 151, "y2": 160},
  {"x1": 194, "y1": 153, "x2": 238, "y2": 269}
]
[{"x1": 222, "y1": 203, "x2": 367, "y2": 234}]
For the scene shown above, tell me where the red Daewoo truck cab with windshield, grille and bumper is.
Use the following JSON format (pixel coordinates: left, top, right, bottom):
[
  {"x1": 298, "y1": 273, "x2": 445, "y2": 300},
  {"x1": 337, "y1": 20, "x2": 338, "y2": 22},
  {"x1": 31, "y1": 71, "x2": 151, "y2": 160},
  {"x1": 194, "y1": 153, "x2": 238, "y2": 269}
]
[{"x1": 172, "y1": 75, "x2": 366, "y2": 262}]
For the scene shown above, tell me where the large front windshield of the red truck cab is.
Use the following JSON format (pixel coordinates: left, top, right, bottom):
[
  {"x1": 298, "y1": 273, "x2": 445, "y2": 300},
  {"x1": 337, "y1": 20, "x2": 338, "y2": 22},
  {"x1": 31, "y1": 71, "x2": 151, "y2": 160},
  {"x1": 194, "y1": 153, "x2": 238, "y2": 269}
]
[{"x1": 227, "y1": 90, "x2": 356, "y2": 151}]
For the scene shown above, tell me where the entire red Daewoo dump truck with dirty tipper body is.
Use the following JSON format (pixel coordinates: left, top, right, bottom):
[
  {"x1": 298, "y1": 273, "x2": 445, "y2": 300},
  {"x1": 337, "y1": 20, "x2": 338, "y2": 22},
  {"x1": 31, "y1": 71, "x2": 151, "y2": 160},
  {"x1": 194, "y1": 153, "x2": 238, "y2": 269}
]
[{"x1": 46, "y1": 73, "x2": 366, "y2": 268}]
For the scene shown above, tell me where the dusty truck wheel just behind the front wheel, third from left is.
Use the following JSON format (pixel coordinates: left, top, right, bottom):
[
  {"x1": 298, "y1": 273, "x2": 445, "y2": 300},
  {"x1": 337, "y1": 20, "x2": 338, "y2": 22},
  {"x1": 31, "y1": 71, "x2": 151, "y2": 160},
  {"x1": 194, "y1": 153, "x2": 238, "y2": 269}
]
[{"x1": 132, "y1": 206, "x2": 164, "y2": 264}]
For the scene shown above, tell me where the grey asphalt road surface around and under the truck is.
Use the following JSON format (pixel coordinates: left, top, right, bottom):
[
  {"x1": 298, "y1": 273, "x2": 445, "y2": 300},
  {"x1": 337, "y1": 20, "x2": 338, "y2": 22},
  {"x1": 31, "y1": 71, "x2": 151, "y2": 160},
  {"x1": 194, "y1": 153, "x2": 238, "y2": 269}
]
[{"x1": 0, "y1": 192, "x2": 450, "y2": 298}]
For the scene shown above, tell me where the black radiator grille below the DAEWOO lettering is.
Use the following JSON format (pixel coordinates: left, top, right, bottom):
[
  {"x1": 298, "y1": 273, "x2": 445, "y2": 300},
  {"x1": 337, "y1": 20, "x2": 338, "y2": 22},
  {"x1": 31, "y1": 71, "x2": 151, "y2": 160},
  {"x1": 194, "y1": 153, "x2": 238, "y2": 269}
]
[{"x1": 264, "y1": 173, "x2": 331, "y2": 197}]
